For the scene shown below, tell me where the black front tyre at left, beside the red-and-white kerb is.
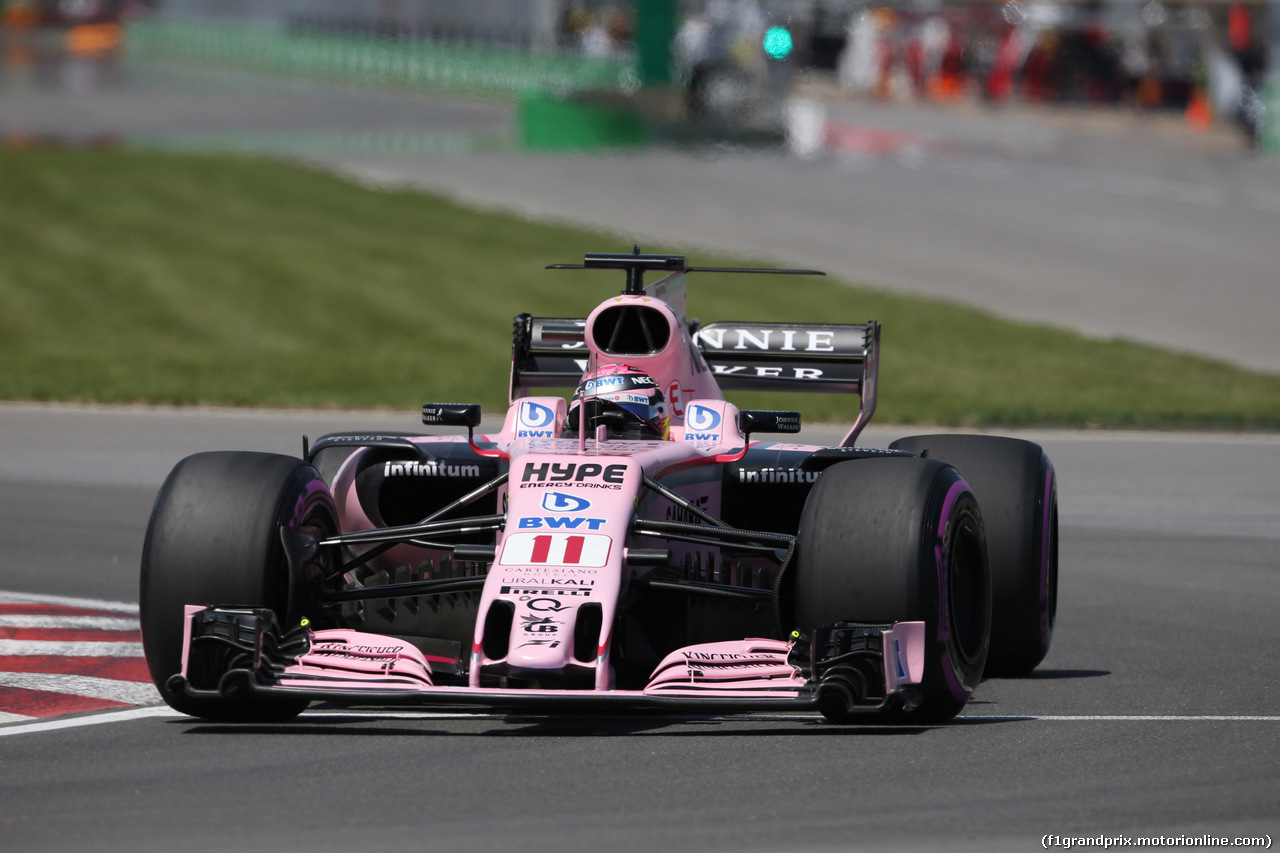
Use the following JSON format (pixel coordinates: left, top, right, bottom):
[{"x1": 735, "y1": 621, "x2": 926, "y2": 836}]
[{"x1": 138, "y1": 452, "x2": 338, "y2": 722}]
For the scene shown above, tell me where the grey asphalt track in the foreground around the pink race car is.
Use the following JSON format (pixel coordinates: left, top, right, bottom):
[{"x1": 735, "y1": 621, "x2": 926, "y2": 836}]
[{"x1": 0, "y1": 406, "x2": 1280, "y2": 850}]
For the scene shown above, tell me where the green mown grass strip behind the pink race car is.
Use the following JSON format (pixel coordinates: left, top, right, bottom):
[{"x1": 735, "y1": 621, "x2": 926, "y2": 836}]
[{"x1": 0, "y1": 151, "x2": 1280, "y2": 429}]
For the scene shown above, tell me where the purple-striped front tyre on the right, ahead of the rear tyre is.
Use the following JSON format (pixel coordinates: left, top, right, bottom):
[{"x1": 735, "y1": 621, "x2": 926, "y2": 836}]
[{"x1": 792, "y1": 457, "x2": 991, "y2": 722}]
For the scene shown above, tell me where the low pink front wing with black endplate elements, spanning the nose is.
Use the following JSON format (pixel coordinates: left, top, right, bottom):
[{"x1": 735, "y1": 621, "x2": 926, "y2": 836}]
[{"x1": 168, "y1": 606, "x2": 924, "y2": 713}]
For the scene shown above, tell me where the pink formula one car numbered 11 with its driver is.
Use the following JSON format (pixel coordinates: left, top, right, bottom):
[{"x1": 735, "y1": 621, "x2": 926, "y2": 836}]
[{"x1": 141, "y1": 250, "x2": 1057, "y2": 722}]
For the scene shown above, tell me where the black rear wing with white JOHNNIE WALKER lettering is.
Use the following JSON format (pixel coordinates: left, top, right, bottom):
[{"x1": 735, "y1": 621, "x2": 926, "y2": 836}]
[{"x1": 511, "y1": 314, "x2": 881, "y2": 446}]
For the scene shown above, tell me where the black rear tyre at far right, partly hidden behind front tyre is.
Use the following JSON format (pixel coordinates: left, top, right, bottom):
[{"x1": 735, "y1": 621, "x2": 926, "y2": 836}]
[{"x1": 891, "y1": 435, "x2": 1057, "y2": 678}]
